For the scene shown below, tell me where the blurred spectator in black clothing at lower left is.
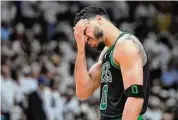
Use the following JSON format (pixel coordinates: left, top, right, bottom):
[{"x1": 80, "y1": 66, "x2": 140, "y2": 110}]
[{"x1": 27, "y1": 78, "x2": 48, "y2": 120}]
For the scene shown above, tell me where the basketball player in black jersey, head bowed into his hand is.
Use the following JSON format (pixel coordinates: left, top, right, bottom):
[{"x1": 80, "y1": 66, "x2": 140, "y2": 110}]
[{"x1": 74, "y1": 6, "x2": 150, "y2": 120}]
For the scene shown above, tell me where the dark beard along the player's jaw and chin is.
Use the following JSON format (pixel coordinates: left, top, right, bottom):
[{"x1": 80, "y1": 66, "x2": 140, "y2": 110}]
[{"x1": 94, "y1": 26, "x2": 105, "y2": 51}]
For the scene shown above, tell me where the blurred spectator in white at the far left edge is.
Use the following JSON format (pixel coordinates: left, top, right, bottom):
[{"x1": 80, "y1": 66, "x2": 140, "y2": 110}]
[{"x1": 0, "y1": 65, "x2": 19, "y2": 120}]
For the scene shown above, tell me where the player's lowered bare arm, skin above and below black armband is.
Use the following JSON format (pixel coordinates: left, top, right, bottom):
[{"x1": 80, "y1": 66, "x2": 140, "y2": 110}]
[{"x1": 113, "y1": 36, "x2": 144, "y2": 120}]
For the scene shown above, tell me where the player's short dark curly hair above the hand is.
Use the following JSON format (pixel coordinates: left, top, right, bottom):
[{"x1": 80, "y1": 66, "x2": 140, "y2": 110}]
[{"x1": 74, "y1": 5, "x2": 110, "y2": 25}]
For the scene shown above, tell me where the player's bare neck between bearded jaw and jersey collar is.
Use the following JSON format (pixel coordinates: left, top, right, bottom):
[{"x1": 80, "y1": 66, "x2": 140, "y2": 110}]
[{"x1": 104, "y1": 24, "x2": 120, "y2": 47}]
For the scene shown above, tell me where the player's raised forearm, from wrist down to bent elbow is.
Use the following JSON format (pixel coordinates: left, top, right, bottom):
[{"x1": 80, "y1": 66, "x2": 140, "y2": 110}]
[{"x1": 74, "y1": 50, "x2": 92, "y2": 98}]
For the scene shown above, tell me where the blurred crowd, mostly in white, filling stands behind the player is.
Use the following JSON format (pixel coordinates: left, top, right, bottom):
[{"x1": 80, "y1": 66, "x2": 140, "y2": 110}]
[{"x1": 0, "y1": 1, "x2": 178, "y2": 120}]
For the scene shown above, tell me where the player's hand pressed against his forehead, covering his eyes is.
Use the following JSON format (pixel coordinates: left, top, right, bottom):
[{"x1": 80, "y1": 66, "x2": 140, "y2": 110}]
[{"x1": 73, "y1": 19, "x2": 89, "y2": 50}]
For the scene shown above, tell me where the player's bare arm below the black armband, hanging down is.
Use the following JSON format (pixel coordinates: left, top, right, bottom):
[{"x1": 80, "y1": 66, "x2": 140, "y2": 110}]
[{"x1": 122, "y1": 97, "x2": 143, "y2": 120}]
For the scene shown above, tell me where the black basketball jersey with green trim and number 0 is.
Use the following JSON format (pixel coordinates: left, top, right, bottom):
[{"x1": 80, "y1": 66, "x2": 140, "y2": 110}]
[{"x1": 100, "y1": 32, "x2": 149, "y2": 120}]
